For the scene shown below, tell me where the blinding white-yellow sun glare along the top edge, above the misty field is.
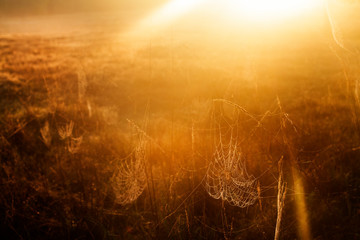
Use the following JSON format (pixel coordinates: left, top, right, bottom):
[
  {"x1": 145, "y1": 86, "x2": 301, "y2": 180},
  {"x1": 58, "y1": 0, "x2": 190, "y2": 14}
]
[{"x1": 129, "y1": 0, "x2": 324, "y2": 35}]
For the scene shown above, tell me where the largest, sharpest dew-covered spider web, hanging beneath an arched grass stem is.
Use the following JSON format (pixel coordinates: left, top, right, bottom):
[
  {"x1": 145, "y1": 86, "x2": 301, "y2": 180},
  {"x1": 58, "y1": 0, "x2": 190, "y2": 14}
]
[{"x1": 205, "y1": 100, "x2": 258, "y2": 208}]
